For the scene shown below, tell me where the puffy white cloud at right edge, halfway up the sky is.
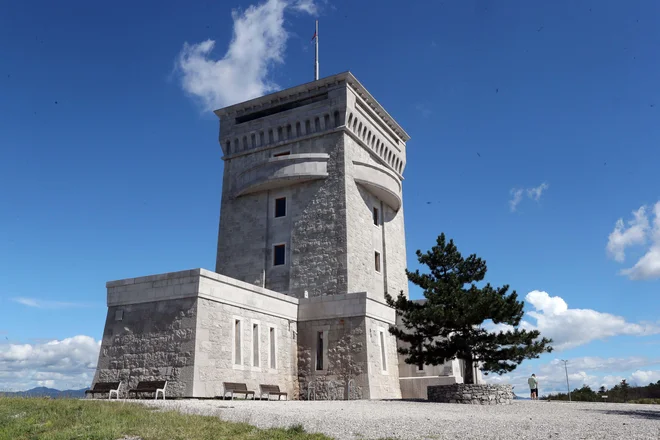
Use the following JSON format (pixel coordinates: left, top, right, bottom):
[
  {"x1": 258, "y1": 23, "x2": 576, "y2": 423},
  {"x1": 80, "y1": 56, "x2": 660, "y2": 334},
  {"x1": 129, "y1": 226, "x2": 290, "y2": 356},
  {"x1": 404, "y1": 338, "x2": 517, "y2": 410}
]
[{"x1": 607, "y1": 202, "x2": 660, "y2": 280}]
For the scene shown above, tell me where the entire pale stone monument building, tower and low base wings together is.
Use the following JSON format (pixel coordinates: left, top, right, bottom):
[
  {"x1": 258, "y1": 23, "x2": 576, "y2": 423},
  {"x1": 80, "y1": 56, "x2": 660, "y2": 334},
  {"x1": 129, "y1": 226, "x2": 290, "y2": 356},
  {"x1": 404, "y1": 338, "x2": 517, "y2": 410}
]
[{"x1": 94, "y1": 72, "x2": 474, "y2": 399}]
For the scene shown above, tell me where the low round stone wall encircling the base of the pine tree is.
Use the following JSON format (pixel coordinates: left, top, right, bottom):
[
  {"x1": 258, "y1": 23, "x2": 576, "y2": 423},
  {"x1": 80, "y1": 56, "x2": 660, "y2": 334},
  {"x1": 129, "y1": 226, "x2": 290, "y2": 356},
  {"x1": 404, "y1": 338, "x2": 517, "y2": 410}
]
[{"x1": 428, "y1": 383, "x2": 513, "y2": 405}]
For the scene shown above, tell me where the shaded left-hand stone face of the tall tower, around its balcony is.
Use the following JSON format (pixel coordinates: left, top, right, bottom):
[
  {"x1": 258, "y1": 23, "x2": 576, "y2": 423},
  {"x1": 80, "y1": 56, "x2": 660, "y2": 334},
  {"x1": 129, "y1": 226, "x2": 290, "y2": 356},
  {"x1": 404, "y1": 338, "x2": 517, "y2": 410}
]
[{"x1": 216, "y1": 86, "x2": 346, "y2": 297}]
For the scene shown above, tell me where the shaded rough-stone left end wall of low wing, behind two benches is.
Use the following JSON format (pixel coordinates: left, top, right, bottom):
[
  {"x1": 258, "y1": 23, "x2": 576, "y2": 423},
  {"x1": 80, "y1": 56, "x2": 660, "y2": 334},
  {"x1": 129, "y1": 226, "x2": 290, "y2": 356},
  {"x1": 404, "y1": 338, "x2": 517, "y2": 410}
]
[{"x1": 94, "y1": 298, "x2": 197, "y2": 397}]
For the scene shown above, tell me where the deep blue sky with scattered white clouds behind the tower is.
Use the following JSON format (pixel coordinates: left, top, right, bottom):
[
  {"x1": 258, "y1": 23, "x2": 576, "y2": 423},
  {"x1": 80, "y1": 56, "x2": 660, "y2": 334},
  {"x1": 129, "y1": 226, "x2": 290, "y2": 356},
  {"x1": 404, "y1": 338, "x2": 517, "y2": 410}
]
[{"x1": 0, "y1": 0, "x2": 660, "y2": 391}]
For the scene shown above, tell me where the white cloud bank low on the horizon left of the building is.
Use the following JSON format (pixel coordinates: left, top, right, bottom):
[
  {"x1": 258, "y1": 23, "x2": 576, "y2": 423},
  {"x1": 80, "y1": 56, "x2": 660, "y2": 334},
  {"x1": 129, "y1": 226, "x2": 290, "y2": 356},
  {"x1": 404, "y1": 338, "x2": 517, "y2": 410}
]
[{"x1": 0, "y1": 335, "x2": 101, "y2": 391}]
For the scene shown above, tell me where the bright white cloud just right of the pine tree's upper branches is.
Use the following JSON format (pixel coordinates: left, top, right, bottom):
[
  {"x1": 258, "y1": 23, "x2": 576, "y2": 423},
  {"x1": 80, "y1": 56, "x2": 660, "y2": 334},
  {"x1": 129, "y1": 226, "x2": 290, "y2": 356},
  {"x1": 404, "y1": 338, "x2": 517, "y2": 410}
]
[{"x1": 485, "y1": 290, "x2": 660, "y2": 350}]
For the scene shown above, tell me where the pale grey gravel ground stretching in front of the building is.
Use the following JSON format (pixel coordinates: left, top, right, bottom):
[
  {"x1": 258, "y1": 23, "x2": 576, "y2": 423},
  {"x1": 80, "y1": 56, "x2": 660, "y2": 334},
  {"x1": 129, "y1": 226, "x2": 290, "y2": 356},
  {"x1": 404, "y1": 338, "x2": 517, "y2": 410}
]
[{"x1": 135, "y1": 400, "x2": 660, "y2": 440}]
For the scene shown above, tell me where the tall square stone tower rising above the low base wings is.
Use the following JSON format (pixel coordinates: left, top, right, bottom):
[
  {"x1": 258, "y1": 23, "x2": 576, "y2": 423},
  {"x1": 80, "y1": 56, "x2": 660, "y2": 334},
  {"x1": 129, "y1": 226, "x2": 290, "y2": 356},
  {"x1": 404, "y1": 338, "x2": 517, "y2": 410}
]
[{"x1": 215, "y1": 72, "x2": 409, "y2": 298}]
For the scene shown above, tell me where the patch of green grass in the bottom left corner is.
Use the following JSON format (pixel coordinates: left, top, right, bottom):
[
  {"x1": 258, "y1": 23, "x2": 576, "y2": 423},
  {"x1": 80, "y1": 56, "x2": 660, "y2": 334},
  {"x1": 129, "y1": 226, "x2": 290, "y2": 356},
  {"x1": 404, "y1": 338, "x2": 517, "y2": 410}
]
[{"x1": 0, "y1": 397, "x2": 329, "y2": 440}]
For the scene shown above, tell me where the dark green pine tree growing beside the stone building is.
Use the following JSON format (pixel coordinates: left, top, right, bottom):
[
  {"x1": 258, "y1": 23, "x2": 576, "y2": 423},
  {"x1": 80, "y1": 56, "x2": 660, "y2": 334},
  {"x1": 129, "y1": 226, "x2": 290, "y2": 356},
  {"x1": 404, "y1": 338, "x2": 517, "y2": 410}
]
[{"x1": 385, "y1": 233, "x2": 552, "y2": 383}]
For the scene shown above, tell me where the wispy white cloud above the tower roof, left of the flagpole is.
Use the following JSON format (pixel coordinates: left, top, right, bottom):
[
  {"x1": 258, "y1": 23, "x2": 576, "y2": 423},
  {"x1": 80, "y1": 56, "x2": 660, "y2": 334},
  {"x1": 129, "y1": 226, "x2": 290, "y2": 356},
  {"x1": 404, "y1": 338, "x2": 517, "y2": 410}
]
[{"x1": 176, "y1": 0, "x2": 318, "y2": 110}]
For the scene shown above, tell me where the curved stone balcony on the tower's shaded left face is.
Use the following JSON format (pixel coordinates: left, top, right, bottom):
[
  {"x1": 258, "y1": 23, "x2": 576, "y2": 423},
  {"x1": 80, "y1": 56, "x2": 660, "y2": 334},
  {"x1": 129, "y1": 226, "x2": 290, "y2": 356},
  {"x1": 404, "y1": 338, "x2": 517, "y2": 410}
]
[{"x1": 234, "y1": 153, "x2": 329, "y2": 197}]
